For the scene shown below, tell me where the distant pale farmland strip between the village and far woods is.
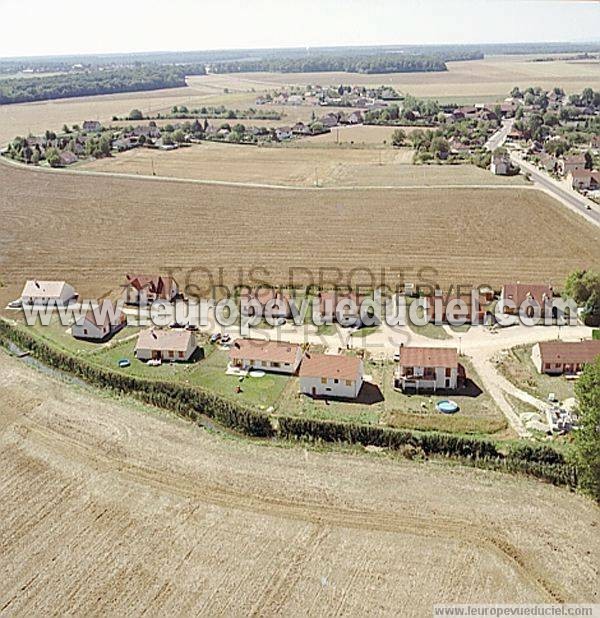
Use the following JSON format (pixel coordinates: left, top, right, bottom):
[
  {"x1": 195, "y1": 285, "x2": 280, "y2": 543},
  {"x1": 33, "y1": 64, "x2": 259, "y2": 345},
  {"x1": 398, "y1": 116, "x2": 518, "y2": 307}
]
[{"x1": 0, "y1": 56, "x2": 600, "y2": 144}]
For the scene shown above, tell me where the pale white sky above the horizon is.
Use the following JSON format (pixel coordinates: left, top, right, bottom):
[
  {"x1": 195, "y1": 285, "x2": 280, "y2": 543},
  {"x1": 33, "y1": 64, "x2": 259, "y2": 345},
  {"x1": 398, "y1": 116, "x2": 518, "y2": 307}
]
[{"x1": 0, "y1": 0, "x2": 600, "y2": 57}]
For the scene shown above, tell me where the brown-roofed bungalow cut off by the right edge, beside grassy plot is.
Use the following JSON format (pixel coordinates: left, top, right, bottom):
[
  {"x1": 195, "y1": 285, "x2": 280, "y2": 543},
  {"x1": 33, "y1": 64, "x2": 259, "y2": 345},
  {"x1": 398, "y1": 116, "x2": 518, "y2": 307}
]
[{"x1": 531, "y1": 340, "x2": 600, "y2": 375}]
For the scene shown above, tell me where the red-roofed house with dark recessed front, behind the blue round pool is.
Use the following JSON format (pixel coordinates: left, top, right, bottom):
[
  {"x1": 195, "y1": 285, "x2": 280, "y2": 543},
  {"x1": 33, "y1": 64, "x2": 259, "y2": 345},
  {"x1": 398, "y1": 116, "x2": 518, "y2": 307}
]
[{"x1": 394, "y1": 346, "x2": 463, "y2": 392}]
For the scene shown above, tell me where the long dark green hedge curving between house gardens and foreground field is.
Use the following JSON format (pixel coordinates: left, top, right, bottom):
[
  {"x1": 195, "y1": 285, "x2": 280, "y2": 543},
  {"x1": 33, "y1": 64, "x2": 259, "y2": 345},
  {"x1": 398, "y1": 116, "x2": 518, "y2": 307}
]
[{"x1": 0, "y1": 319, "x2": 577, "y2": 487}]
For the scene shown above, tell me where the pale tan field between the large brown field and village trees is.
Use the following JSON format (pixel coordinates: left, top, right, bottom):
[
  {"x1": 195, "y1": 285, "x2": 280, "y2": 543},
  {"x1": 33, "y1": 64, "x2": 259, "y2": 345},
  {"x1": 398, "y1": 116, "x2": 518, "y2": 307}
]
[{"x1": 77, "y1": 141, "x2": 525, "y2": 187}]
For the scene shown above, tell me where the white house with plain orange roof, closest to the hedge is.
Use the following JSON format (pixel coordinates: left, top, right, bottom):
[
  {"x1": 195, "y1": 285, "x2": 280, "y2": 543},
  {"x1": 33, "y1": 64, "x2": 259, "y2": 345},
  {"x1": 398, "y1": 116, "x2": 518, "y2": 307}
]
[{"x1": 299, "y1": 352, "x2": 364, "y2": 399}]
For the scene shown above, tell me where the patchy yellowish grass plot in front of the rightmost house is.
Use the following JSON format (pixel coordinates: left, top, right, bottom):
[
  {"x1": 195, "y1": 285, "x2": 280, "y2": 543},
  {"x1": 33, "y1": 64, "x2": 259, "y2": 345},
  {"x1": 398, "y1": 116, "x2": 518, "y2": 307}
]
[{"x1": 498, "y1": 345, "x2": 575, "y2": 401}]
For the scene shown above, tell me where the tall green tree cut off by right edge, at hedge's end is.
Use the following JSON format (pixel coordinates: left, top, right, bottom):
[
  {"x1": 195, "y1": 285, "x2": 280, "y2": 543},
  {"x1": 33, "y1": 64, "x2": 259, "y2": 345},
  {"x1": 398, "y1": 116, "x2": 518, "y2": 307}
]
[{"x1": 574, "y1": 356, "x2": 600, "y2": 502}]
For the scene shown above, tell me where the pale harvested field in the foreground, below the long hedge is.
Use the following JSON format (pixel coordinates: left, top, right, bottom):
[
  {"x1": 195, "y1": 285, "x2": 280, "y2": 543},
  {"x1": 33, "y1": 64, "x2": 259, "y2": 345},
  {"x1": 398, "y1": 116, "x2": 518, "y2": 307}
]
[{"x1": 0, "y1": 352, "x2": 600, "y2": 616}]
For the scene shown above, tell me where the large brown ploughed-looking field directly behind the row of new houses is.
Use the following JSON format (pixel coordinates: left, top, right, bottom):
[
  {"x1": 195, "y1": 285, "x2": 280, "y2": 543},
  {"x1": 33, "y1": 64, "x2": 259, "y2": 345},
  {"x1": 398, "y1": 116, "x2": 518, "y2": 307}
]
[{"x1": 0, "y1": 164, "x2": 600, "y2": 306}]
